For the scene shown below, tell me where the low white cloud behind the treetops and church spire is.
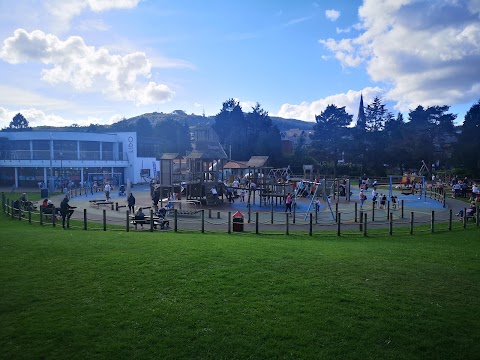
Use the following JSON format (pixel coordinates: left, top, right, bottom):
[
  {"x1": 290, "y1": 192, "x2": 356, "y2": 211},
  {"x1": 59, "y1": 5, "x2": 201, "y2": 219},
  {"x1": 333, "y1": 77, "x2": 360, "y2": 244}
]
[{"x1": 272, "y1": 87, "x2": 383, "y2": 121}]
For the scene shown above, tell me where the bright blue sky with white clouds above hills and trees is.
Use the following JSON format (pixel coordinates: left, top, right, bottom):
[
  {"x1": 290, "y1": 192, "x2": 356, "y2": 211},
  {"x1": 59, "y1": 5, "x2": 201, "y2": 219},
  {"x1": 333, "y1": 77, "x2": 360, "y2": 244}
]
[{"x1": 0, "y1": 0, "x2": 480, "y2": 128}]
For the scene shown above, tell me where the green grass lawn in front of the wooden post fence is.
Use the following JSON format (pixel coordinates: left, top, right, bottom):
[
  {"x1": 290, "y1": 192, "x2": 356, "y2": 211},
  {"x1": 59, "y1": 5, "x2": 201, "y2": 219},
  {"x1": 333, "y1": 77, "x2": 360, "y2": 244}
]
[{"x1": 0, "y1": 215, "x2": 480, "y2": 359}]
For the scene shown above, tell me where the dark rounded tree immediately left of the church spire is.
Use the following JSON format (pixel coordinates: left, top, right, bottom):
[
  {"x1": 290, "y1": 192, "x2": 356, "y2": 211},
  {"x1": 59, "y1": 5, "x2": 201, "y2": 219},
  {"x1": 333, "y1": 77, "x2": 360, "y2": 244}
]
[{"x1": 311, "y1": 105, "x2": 353, "y2": 176}]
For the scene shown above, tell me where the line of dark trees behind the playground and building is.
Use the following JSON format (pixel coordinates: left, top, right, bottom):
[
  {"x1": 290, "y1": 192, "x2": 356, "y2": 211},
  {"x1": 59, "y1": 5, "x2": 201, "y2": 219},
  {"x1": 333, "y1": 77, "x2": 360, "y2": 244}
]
[{"x1": 4, "y1": 97, "x2": 480, "y2": 177}]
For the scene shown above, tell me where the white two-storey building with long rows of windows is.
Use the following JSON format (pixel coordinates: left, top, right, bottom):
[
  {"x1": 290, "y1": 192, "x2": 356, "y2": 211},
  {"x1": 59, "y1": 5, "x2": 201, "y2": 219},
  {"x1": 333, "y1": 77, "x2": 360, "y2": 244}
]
[{"x1": 0, "y1": 131, "x2": 159, "y2": 189}]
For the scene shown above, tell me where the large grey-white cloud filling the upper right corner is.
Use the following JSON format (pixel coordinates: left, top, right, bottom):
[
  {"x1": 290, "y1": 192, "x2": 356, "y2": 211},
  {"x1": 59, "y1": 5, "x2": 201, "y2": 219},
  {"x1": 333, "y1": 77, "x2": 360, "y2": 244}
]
[{"x1": 320, "y1": 0, "x2": 480, "y2": 109}]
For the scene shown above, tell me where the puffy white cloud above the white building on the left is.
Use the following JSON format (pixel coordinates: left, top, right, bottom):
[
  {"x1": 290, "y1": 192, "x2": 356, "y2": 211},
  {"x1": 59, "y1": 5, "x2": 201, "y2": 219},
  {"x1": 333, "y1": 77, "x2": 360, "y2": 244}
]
[{"x1": 0, "y1": 29, "x2": 174, "y2": 105}]
